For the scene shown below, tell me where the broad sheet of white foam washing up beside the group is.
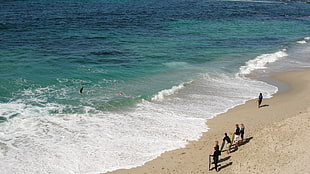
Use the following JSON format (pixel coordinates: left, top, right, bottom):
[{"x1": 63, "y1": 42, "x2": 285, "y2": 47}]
[{"x1": 0, "y1": 101, "x2": 205, "y2": 173}]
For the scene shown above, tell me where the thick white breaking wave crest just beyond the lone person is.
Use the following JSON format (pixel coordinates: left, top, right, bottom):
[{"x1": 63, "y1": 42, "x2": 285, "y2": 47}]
[{"x1": 237, "y1": 49, "x2": 288, "y2": 76}]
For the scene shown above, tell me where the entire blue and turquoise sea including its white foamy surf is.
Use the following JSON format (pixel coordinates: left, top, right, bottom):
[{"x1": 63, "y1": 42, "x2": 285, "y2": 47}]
[{"x1": 0, "y1": 0, "x2": 310, "y2": 173}]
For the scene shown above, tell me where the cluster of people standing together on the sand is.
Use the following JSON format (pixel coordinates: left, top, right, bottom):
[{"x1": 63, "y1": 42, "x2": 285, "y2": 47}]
[{"x1": 210, "y1": 124, "x2": 245, "y2": 172}]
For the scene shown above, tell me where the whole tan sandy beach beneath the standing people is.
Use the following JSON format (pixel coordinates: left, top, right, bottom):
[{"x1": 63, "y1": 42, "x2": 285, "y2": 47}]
[{"x1": 105, "y1": 70, "x2": 310, "y2": 174}]
